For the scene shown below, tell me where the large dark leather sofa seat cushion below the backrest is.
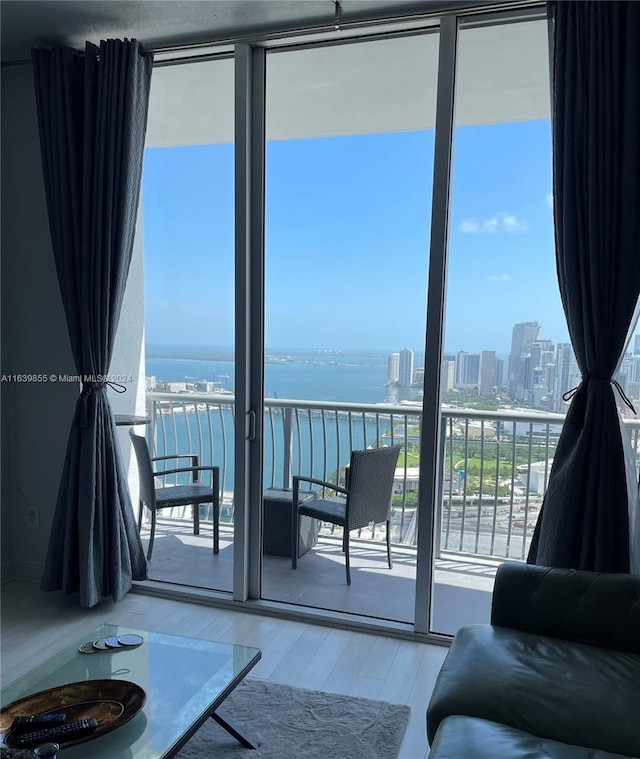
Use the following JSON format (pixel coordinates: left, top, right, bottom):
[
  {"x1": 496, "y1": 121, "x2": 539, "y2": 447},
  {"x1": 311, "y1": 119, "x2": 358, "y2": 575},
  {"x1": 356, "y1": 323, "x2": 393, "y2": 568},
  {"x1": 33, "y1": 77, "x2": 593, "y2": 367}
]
[{"x1": 427, "y1": 625, "x2": 640, "y2": 756}]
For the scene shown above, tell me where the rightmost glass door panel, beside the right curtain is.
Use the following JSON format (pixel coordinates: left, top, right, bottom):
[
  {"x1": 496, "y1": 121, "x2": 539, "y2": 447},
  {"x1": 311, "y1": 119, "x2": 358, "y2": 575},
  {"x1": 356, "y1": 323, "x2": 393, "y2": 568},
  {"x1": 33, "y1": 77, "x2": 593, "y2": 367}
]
[{"x1": 431, "y1": 19, "x2": 560, "y2": 634}]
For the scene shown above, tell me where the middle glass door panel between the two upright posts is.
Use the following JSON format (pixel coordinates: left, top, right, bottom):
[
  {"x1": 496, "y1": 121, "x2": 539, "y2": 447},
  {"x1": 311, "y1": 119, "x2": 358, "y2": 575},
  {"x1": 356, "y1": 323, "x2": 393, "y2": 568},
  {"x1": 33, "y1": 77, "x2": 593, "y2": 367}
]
[{"x1": 262, "y1": 29, "x2": 438, "y2": 622}]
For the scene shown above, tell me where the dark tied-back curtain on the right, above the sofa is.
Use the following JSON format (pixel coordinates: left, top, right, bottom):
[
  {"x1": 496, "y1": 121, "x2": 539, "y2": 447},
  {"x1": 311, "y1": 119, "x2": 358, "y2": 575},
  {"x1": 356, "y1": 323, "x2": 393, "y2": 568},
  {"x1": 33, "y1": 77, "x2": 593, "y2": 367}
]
[{"x1": 528, "y1": 2, "x2": 640, "y2": 572}]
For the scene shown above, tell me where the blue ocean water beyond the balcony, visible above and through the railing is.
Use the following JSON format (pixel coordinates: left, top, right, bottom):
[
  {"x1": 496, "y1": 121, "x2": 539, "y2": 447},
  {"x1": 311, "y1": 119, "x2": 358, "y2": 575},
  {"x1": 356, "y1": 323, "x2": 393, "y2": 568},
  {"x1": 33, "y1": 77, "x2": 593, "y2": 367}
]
[{"x1": 145, "y1": 346, "x2": 418, "y2": 492}]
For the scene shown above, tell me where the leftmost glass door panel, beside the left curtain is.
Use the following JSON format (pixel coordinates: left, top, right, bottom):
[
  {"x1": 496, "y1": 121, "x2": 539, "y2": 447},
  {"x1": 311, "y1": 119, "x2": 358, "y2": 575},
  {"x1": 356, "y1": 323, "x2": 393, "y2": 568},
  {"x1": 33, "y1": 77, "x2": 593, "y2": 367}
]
[{"x1": 138, "y1": 58, "x2": 235, "y2": 591}]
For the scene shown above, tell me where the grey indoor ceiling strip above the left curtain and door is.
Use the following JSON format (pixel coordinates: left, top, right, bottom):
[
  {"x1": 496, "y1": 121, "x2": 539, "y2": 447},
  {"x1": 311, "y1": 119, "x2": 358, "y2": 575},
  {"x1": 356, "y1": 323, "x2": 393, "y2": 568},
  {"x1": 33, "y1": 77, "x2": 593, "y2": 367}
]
[{"x1": 0, "y1": 0, "x2": 450, "y2": 62}]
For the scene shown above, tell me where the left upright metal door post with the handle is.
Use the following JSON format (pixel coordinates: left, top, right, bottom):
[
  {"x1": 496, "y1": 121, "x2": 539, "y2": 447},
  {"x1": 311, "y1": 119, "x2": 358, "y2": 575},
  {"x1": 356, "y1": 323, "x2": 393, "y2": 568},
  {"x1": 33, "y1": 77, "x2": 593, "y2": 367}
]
[{"x1": 233, "y1": 43, "x2": 265, "y2": 601}]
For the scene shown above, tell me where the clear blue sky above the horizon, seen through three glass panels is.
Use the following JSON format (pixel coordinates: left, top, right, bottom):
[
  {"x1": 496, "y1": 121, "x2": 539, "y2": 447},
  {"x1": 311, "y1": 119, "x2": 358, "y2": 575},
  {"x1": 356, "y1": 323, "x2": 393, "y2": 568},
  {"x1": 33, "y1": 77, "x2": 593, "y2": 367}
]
[{"x1": 142, "y1": 120, "x2": 567, "y2": 352}]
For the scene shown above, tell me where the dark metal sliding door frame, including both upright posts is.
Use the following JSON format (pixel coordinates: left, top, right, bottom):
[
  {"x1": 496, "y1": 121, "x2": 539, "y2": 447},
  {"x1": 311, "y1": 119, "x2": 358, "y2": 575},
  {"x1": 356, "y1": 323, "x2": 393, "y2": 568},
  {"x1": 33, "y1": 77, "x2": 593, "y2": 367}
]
[{"x1": 233, "y1": 2, "x2": 546, "y2": 643}]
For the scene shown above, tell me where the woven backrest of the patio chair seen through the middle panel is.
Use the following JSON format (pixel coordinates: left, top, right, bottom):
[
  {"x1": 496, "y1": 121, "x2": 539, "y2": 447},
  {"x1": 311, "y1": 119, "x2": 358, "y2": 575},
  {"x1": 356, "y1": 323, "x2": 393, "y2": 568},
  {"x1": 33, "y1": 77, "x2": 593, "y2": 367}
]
[{"x1": 347, "y1": 445, "x2": 401, "y2": 530}]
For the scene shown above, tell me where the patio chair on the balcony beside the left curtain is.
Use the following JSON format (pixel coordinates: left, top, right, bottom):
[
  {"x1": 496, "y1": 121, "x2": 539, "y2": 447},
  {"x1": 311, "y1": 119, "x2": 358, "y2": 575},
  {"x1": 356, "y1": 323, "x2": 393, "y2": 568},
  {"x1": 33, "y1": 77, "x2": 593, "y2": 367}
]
[{"x1": 129, "y1": 430, "x2": 220, "y2": 561}]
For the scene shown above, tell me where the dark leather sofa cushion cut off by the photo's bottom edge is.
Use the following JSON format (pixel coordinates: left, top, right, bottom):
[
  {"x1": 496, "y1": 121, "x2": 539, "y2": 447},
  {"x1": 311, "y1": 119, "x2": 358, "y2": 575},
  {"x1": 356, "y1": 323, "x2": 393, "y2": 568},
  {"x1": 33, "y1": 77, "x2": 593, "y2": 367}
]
[{"x1": 429, "y1": 716, "x2": 627, "y2": 759}]
